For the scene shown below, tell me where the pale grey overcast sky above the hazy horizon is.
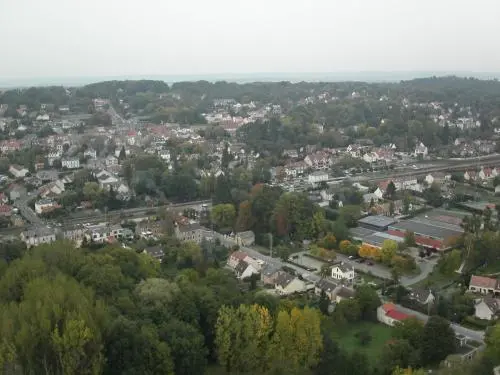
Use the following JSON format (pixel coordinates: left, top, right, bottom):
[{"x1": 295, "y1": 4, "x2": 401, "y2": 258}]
[{"x1": 0, "y1": 0, "x2": 500, "y2": 78}]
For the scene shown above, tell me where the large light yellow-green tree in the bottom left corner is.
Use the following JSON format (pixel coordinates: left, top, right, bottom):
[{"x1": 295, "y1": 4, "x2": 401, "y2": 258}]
[{"x1": 0, "y1": 274, "x2": 107, "y2": 375}]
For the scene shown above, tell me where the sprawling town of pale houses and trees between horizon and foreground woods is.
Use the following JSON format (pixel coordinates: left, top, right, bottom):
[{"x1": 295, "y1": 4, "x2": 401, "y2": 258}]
[{"x1": 0, "y1": 77, "x2": 500, "y2": 374}]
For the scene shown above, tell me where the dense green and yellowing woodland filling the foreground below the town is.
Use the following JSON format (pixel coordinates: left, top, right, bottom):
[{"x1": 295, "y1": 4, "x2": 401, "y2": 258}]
[{"x1": 0, "y1": 237, "x2": 500, "y2": 375}]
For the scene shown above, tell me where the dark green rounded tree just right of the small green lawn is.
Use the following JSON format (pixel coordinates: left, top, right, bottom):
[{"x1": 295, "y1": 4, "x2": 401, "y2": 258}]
[{"x1": 421, "y1": 316, "x2": 456, "y2": 365}]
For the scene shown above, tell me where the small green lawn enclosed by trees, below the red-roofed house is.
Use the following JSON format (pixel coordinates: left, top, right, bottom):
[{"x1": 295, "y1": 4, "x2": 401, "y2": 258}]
[{"x1": 331, "y1": 322, "x2": 392, "y2": 365}]
